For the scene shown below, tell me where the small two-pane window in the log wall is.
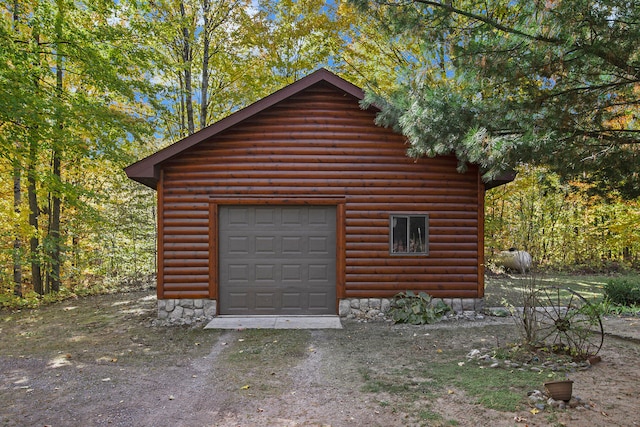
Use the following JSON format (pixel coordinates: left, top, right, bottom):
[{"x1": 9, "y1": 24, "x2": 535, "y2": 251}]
[{"x1": 389, "y1": 214, "x2": 429, "y2": 255}]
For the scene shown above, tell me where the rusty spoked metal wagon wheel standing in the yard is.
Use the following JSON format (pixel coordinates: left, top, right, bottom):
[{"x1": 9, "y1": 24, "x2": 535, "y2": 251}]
[{"x1": 536, "y1": 287, "x2": 604, "y2": 360}]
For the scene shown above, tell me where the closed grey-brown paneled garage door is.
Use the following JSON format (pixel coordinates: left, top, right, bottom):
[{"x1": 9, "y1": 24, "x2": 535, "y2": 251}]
[{"x1": 218, "y1": 205, "x2": 336, "y2": 315}]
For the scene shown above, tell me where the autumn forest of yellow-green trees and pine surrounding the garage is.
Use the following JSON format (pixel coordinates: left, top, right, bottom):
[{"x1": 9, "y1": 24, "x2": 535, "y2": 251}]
[{"x1": 0, "y1": 0, "x2": 640, "y2": 304}]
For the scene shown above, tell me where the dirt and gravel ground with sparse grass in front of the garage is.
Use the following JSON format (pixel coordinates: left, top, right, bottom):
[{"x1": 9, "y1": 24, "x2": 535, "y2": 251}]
[{"x1": 0, "y1": 291, "x2": 640, "y2": 427}]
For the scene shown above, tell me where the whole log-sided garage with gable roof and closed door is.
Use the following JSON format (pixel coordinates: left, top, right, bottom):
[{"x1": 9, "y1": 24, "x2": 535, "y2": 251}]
[{"x1": 126, "y1": 69, "x2": 510, "y2": 315}]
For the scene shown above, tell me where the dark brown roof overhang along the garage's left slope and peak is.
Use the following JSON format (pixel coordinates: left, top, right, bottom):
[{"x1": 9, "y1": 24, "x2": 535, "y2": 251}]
[{"x1": 124, "y1": 68, "x2": 364, "y2": 189}]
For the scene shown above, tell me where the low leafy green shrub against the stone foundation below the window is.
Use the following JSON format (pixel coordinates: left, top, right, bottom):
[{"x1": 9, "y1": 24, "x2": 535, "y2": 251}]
[{"x1": 389, "y1": 291, "x2": 451, "y2": 325}]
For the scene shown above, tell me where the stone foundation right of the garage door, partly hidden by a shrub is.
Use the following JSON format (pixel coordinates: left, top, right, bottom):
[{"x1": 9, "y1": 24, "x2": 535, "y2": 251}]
[{"x1": 338, "y1": 298, "x2": 484, "y2": 320}]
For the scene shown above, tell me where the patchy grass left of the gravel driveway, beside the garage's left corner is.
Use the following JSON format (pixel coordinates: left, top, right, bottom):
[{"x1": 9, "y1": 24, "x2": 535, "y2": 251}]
[{"x1": 0, "y1": 293, "x2": 219, "y2": 367}]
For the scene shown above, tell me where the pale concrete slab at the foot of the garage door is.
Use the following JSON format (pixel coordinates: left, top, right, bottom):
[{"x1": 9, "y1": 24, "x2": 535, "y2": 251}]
[{"x1": 204, "y1": 316, "x2": 342, "y2": 329}]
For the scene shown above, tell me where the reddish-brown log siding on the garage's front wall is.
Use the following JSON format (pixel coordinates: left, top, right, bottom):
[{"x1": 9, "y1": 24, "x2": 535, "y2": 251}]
[{"x1": 158, "y1": 83, "x2": 484, "y2": 298}]
